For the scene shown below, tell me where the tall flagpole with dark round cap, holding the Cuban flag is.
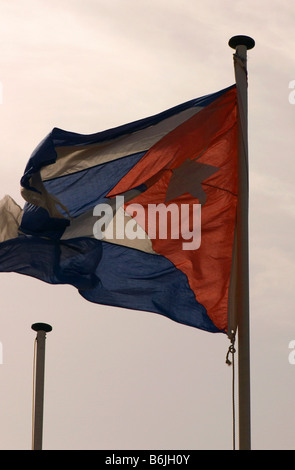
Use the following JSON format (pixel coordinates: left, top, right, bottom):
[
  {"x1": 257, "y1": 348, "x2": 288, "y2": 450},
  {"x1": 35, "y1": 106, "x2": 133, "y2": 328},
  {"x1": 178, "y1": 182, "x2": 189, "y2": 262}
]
[{"x1": 229, "y1": 36, "x2": 255, "y2": 450}]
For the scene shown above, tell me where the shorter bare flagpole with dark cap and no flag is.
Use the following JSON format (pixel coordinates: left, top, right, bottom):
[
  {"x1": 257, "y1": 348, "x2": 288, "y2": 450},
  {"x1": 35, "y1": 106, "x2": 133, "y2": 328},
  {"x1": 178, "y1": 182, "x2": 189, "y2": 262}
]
[{"x1": 32, "y1": 323, "x2": 52, "y2": 450}]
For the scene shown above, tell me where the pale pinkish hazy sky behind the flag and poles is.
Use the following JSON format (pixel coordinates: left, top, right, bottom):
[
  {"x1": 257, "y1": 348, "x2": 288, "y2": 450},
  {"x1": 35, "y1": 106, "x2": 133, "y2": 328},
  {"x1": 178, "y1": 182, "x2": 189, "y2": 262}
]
[{"x1": 0, "y1": 0, "x2": 295, "y2": 450}]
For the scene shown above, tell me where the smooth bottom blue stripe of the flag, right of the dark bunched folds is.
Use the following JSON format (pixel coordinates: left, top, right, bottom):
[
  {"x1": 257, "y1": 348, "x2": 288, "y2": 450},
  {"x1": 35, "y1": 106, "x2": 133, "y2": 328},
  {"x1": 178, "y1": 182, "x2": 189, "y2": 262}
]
[{"x1": 80, "y1": 242, "x2": 220, "y2": 333}]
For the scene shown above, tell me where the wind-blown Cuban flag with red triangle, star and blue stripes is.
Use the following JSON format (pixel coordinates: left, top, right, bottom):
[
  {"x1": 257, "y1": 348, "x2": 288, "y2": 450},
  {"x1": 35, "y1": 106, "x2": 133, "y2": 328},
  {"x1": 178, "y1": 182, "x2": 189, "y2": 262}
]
[{"x1": 0, "y1": 85, "x2": 237, "y2": 333}]
